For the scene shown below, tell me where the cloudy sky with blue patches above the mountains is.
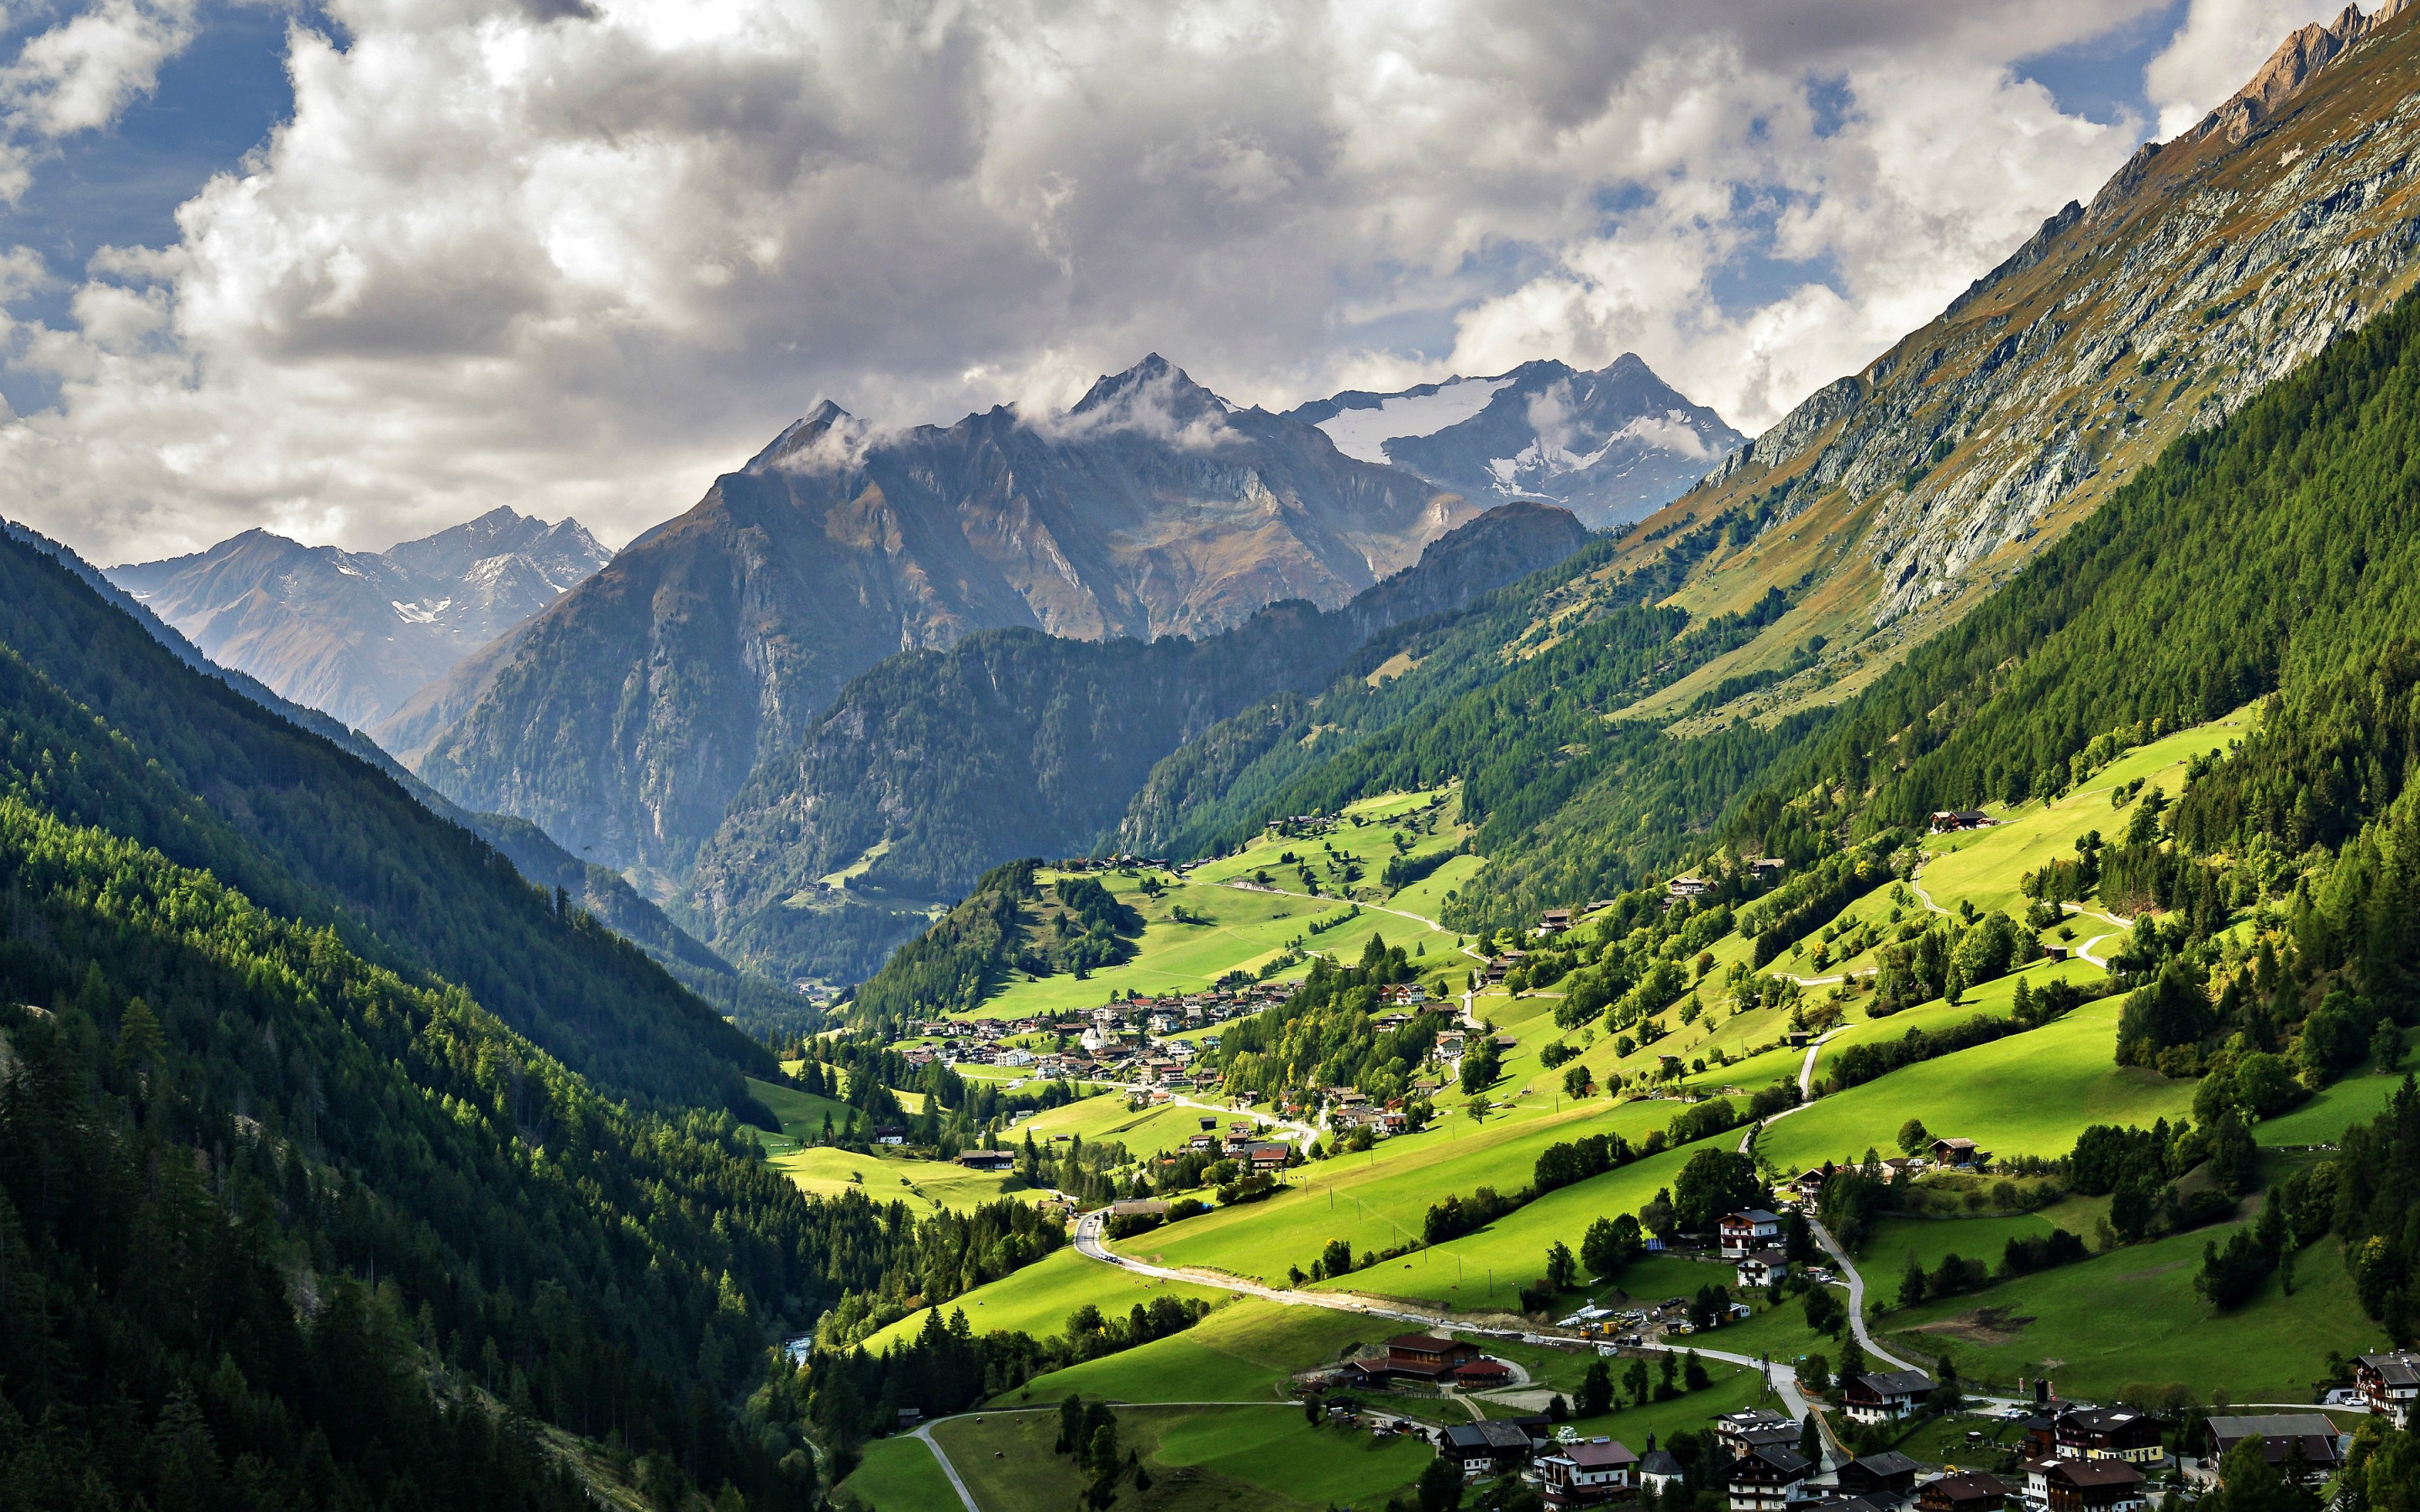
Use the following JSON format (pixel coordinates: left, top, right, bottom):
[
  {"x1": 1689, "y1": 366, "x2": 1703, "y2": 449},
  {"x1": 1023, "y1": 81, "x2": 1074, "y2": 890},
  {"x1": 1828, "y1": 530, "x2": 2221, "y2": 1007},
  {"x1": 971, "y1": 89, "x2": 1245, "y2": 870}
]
[{"x1": 0, "y1": 0, "x2": 2361, "y2": 564}]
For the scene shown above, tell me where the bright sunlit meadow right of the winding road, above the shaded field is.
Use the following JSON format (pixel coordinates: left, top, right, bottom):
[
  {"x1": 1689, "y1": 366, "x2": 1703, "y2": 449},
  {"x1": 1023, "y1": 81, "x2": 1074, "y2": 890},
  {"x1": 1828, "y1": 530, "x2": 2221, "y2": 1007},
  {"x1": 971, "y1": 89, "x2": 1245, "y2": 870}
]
[{"x1": 1757, "y1": 997, "x2": 2195, "y2": 1171}]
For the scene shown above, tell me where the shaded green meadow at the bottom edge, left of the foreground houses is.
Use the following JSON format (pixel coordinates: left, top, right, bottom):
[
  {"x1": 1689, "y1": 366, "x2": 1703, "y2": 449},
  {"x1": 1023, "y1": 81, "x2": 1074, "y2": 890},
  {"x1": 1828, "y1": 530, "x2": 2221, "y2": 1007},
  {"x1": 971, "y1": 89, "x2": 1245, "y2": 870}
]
[{"x1": 934, "y1": 1403, "x2": 1433, "y2": 1512}]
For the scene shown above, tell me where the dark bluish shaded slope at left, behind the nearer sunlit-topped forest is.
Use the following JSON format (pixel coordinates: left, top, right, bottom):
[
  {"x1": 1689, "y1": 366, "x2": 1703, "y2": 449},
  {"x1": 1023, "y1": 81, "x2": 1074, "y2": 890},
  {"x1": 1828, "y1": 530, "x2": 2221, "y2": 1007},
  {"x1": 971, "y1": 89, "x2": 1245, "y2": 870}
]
[{"x1": 0, "y1": 537, "x2": 770, "y2": 1108}]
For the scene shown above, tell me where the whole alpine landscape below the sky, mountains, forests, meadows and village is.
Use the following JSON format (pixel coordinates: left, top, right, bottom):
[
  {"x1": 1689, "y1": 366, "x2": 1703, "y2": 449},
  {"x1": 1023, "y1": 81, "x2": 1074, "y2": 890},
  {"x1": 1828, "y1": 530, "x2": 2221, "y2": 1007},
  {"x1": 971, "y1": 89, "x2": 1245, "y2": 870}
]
[{"x1": 13, "y1": 0, "x2": 2420, "y2": 1512}]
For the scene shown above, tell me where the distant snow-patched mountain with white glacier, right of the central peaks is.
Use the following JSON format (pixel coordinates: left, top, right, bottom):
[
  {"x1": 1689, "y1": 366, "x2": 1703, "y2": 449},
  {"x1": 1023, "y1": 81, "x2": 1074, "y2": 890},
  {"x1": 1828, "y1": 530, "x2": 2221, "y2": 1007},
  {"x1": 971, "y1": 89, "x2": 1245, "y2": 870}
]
[{"x1": 1292, "y1": 353, "x2": 1747, "y2": 528}]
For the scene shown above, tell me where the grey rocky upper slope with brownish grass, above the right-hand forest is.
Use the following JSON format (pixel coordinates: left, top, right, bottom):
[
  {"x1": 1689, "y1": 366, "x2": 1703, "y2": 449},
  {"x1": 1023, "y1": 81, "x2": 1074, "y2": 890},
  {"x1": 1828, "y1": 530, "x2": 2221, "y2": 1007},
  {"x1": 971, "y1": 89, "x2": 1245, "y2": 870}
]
[{"x1": 1672, "y1": 0, "x2": 2420, "y2": 622}]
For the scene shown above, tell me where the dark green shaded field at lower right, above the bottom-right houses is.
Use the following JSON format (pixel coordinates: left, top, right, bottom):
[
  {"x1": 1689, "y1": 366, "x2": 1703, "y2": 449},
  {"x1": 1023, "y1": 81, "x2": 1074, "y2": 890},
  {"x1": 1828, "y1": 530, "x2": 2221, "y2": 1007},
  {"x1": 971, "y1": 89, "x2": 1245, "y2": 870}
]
[{"x1": 1868, "y1": 1224, "x2": 2379, "y2": 1401}]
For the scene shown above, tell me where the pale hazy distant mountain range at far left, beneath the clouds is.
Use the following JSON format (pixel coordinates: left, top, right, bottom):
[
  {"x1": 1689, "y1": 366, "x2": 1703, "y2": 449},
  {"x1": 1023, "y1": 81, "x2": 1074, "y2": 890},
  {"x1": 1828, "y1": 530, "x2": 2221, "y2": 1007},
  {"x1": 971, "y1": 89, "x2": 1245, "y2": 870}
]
[{"x1": 107, "y1": 508, "x2": 613, "y2": 726}]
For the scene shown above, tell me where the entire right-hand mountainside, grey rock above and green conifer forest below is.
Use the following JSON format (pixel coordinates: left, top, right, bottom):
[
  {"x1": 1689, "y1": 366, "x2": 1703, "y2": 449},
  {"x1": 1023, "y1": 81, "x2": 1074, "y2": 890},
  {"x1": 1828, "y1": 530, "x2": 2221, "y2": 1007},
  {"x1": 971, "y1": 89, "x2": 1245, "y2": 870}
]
[{"x1": 1074, "y1": 0, "x2": 2420, "y2": 924}]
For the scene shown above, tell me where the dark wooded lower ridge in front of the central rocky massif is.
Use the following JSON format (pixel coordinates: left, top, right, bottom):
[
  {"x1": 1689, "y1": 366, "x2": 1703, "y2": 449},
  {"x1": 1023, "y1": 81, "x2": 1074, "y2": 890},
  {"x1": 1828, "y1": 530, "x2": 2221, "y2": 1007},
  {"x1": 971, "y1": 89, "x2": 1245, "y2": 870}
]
[{"x1": 685, "y1": 503, "x2": 1585, "y2": 975}]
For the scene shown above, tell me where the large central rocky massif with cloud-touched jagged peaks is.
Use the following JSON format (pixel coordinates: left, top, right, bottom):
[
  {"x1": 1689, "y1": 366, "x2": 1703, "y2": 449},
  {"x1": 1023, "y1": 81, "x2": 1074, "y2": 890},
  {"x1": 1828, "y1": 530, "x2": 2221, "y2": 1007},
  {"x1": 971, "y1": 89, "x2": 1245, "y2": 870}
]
[{"x1": 392, "y1": 355, "x2": 1479, "y2": 871}]
